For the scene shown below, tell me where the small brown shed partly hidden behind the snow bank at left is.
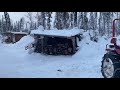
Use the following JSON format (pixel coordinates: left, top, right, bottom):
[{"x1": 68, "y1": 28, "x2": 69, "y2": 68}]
[{"x1": 3, "y1": 32, "x2": 27, "y2": 43}]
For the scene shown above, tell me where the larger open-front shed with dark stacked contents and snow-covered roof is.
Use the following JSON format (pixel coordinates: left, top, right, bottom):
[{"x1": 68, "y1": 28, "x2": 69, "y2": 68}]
[{"x1": 31, "y1": 30, "x2": 82, "y2": 55}]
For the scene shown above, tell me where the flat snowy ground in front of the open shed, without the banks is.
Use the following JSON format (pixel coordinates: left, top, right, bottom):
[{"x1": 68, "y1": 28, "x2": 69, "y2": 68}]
[{"x1": 0, "y1": 44, "x2": 102, "y2": 78}]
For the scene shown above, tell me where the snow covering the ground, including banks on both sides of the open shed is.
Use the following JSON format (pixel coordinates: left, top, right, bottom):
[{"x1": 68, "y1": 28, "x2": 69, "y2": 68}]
[{"x1": 0, "y1": 28, "x2": 117, "y2": 78}]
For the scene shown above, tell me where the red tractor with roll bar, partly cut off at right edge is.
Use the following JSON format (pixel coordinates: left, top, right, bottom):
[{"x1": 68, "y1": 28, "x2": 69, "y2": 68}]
[{"x1": 101, "y1": 19, "x2": 120, "y2": 78}]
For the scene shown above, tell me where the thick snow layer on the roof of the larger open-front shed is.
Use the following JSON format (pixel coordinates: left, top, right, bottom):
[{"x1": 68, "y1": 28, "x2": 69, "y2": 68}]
[{"x1": 31, "y1": 29, "x2": 81, "y2": 37}]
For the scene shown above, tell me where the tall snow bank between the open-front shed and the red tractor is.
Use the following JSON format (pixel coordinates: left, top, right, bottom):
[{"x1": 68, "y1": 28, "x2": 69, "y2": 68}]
[{"x1": 75, "y1": 32, "x2": 110, "y2": 57}]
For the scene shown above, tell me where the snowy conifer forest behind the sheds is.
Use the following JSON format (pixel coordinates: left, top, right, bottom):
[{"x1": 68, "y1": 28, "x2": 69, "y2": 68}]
[{"x1": 0, "y1": 12, "x2": 120, "y2": 41}]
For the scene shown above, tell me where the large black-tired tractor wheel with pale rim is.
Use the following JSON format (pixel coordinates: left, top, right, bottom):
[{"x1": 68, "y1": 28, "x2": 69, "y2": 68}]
[{"x1": 101, "y1": 52, "x2": 120, "y2": 78}]
